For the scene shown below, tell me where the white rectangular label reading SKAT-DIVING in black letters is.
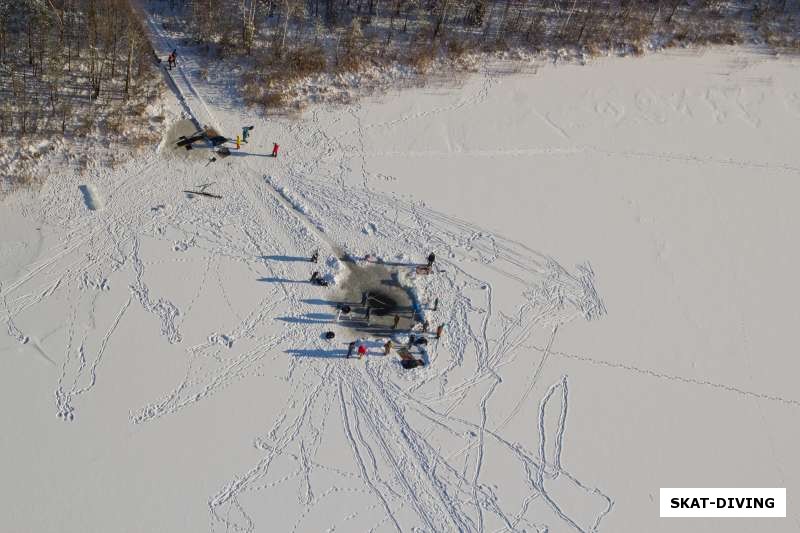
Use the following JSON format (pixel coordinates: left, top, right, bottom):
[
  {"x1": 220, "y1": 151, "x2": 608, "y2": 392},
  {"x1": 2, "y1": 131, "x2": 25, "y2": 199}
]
[{"x1": 659, "y1": 488, "x2": 786, "y2": 518}]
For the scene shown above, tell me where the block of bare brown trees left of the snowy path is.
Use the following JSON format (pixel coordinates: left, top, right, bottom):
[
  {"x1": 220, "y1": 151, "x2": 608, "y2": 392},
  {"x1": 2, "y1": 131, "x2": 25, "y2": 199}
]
[{"x1": 0, "y1": 0, "x2": 161, "y2": 141}]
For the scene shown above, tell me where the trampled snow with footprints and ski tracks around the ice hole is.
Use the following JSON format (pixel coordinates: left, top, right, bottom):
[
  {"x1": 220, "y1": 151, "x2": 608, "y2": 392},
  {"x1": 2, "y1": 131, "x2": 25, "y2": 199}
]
[{"x1": 12, "y1": 5, "x2": 799, "y2": 533}]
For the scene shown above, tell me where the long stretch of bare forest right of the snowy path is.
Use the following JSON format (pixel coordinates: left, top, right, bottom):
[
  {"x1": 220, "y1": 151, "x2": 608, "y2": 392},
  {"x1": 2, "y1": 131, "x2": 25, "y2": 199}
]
[{"x1": 158, "y1": 0, "x2": 800, "y2": 107}]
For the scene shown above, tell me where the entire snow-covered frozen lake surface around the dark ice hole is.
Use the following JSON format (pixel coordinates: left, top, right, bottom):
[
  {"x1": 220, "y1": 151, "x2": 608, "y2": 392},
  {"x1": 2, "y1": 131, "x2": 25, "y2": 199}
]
[{"x1": 0, "y1": 45, "x2": 800, "y2": 533}]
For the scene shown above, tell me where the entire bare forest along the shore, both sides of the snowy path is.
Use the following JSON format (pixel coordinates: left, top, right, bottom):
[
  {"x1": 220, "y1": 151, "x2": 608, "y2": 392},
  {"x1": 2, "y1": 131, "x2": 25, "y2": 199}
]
[{"x1": 0, "y1": 0, "x2": 800, "y2": 137}]
